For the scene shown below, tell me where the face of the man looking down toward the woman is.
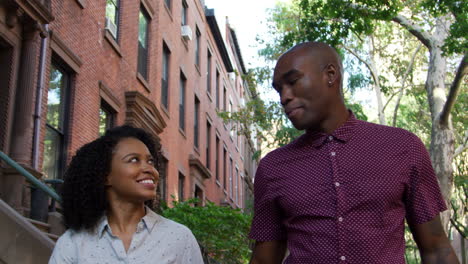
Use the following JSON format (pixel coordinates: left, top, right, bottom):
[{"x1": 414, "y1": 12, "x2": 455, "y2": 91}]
[{"x1": 273, "y1": 49, "x2": 331, "y2": 130}]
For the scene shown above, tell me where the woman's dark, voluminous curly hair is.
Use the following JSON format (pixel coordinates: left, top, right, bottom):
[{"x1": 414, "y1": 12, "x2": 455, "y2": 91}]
[{"x1": 61, "y1": 125, "x2": 161, "y2": 231}]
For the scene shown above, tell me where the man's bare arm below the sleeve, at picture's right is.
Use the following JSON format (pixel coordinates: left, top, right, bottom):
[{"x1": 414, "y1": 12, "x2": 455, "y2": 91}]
[{"x1": 409, "y1": 215, "x2": 459, "y2": 264}]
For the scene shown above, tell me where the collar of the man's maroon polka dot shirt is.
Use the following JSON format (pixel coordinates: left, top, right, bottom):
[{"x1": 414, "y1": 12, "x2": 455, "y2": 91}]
[{"x1": 304, "y1": 110, "x2": 359, "y2": 148}]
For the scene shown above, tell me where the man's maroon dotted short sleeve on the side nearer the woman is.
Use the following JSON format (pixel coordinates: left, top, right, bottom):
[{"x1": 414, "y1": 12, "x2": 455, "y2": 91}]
[{"x1": 249, "y1": 157, "x2": 286, "y2": 241}]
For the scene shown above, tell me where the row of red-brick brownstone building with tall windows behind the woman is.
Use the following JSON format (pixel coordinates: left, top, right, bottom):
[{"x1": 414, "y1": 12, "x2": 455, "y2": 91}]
[{"x1": 0, "y1": 0, "x2": 257, "y2": 229}]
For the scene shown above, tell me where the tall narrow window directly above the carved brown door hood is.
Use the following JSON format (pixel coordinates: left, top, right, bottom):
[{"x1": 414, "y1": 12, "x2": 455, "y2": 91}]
[{"x1": 138, "y1": 8, "x2": 149, "y2": 80}]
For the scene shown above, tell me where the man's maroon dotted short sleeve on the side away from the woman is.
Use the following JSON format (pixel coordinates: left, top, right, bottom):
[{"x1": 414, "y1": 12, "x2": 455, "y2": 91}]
[{"x1": 405, "y1": 136, "x2": 447, "y2": 224}]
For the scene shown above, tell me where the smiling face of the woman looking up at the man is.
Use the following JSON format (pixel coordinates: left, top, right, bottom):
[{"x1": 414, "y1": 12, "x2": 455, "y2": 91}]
[{"x1": 107, "y1": 138, "x2": 159, "y2": 202}]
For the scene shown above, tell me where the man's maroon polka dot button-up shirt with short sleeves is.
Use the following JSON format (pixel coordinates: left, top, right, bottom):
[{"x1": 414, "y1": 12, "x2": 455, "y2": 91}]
[{"x1": 250, "y1": 114, "x2": 446, "y2": 264}]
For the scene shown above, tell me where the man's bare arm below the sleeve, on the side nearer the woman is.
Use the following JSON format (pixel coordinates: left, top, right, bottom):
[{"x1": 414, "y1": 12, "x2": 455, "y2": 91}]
[{"x1": 250, "y1": 240, "x2": 286, "y2": 264}]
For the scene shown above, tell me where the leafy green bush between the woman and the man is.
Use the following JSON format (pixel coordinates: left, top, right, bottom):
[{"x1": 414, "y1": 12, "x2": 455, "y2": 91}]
[{"x1": 162, "y1": 199, "x2": 252, "y2": 264}]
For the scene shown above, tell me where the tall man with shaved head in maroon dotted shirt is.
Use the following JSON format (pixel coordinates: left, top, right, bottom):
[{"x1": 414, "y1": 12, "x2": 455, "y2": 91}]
[{"x1": 250, "y1": 42, "x2": 458, "y2": 264}]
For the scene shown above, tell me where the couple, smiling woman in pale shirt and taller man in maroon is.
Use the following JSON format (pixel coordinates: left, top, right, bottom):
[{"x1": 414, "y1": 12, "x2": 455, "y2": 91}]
[{"x1": 51, "y1": 42, "x2": 458, "y2": 264}]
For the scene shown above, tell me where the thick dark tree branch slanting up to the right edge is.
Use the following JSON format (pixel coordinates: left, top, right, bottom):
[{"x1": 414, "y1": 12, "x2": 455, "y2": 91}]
[{"x1": 439, "y1": 53, "x2": 468, "y2": 126}]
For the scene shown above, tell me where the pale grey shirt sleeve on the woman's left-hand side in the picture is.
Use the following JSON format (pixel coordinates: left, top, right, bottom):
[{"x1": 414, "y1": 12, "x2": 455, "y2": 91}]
[{"x1": 49, "y1": 230, "x2": 78, "y2": 264}]
